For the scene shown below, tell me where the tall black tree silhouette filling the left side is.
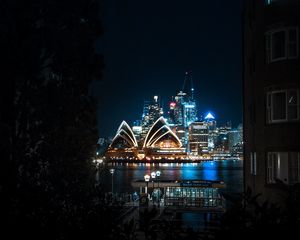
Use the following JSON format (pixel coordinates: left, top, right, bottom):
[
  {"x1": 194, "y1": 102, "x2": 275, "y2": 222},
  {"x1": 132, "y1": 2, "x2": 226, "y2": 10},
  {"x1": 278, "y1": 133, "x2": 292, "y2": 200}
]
[{"x1": 0, "y1": 0, "x2": 103, "y2": 239}]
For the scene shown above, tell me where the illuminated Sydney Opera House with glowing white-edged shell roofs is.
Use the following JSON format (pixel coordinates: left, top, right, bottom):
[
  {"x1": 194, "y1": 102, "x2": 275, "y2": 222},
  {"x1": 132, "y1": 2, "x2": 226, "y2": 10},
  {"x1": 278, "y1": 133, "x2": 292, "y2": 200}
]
[{"x1": 106, "y1": 117, "x2": 186, "y2": 160}]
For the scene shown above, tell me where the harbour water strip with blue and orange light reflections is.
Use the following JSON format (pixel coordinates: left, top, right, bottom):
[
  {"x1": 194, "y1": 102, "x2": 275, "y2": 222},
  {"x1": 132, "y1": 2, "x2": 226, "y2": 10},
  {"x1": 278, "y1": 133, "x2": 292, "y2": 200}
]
[{"x1": 102, "y1": 160, "x2": 243, "y2": 193}]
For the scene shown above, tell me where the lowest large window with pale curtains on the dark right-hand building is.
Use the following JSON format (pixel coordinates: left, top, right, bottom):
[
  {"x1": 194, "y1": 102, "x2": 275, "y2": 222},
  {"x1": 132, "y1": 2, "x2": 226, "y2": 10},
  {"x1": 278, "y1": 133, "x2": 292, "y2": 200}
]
[{"x1": 267, "y1": 152, "x2": 300, "y2": 184}]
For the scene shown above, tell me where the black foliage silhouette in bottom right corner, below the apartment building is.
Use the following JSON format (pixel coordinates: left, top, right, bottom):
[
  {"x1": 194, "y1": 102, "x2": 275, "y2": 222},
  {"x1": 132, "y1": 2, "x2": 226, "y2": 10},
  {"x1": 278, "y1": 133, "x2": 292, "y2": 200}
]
[{"x1": 216, "y1": 187, "x2": 300, "y2": 239}]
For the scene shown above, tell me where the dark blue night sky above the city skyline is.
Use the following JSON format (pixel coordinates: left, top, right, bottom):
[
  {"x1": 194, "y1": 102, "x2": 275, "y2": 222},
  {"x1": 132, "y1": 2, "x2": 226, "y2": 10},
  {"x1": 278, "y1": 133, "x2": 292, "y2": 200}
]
[{"x1": 92, "y1": 0, "x2": 242, "y2": 137}]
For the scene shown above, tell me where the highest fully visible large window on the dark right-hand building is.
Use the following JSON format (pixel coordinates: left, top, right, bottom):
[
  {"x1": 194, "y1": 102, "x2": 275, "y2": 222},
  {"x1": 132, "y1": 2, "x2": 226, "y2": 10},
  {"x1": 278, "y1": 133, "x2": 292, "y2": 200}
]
[{"x1": 266, "y1": 27, "x2": 299, "y2": 63}]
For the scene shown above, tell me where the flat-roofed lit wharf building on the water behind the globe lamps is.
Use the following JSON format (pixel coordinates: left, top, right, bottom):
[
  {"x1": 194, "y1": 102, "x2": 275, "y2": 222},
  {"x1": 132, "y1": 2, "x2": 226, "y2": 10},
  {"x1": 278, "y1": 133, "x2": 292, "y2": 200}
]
[{"x1": 131, "y1": 180, "x2": 226, "y2": 212}]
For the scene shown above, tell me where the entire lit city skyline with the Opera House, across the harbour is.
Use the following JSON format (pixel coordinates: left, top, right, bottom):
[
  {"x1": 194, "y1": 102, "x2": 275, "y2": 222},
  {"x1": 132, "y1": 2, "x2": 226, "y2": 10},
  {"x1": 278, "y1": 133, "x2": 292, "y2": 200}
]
[{"x1": 106, "y1": 71, "x2": 243, "y2": 161}]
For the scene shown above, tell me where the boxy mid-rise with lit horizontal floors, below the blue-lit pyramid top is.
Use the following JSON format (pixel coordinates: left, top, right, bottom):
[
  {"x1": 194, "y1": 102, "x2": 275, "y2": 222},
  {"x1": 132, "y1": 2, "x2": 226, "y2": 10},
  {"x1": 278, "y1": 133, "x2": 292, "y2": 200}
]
[{"x1": 189, "y1": 122, "x2": 208, "y2": 155}]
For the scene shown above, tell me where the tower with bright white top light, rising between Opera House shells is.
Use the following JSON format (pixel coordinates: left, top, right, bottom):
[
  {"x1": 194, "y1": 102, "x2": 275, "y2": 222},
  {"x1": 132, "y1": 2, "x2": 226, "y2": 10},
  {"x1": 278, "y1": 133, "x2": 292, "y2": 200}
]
[{"x1": 141, "y1": 96, "x2": 163, "y2": 139}]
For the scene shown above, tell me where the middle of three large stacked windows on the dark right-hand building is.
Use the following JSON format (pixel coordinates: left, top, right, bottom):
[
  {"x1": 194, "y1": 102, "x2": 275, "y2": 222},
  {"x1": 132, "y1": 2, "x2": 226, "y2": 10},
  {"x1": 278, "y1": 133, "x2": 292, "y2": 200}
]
[{"x1": 267, "y1": 89, "x2": 299, "y2": 123}]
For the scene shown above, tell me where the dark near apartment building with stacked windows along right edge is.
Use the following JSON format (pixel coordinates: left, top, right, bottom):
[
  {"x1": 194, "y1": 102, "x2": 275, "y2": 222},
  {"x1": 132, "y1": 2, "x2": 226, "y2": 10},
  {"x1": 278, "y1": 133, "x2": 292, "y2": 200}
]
[{"x1": 243, "y1": 0, "x2": 300, "y2": 205}]
